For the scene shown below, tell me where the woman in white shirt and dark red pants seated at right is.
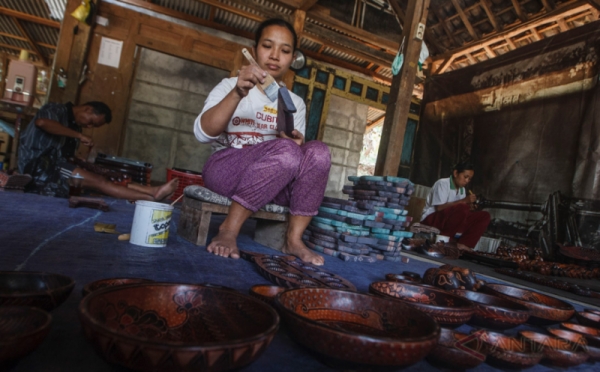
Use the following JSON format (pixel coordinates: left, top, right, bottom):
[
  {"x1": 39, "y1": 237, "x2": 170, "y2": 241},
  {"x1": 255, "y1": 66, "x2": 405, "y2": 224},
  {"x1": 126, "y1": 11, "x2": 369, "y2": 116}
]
[{"x1": 421, "y1": 162, "x2": 490, "y2": 250}]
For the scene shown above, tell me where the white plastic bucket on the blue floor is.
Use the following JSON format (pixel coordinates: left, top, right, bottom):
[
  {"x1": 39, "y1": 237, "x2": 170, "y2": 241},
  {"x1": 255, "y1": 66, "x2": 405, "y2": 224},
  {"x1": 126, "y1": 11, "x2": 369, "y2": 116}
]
[{"x1": 129, "y1": 200, "x2": 173, "y2": 248}]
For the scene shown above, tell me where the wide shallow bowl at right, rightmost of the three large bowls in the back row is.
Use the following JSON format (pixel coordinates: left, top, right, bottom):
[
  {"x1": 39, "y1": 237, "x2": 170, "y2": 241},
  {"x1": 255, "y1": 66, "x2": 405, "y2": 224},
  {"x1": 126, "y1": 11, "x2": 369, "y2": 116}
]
[{"x1": 480, "y1": 283, "x2": 575, "y2": 325}]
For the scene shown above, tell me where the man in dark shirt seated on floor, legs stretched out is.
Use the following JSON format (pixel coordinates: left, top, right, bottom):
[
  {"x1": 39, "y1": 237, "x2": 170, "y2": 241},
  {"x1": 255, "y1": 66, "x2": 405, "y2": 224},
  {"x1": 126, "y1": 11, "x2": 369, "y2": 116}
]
[{"x1": 18, "y1": 102, "x2": 178, "y2": 201}]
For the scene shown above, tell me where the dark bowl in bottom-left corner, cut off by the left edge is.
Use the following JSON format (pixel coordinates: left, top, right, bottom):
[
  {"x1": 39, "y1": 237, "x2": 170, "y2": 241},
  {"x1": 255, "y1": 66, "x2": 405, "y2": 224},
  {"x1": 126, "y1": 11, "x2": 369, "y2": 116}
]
[{"x1": 0, "y1": 306, "x2": 52, "y2": 364}]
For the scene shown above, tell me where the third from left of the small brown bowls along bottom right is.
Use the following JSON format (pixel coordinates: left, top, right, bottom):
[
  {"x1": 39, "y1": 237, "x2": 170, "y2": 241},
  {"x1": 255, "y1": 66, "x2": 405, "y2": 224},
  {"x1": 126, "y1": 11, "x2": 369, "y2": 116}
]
[{"x1": 519, "y1": 331, "x2": 589, "y2": 368}]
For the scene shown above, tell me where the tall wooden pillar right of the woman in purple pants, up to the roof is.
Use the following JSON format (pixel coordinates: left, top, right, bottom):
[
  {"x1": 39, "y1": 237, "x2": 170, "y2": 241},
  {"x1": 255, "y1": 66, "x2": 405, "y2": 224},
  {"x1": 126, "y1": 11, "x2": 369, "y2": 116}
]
[{"x1": 375, "y1": 0, "x2": 430, "y2": 176}]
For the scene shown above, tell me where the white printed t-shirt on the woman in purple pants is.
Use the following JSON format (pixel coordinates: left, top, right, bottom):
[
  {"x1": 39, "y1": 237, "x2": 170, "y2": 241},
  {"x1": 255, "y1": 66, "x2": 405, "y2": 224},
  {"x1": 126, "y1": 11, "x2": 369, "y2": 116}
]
[{"x1": 194, "y1": 77, "x2": 306, "y2": 153}]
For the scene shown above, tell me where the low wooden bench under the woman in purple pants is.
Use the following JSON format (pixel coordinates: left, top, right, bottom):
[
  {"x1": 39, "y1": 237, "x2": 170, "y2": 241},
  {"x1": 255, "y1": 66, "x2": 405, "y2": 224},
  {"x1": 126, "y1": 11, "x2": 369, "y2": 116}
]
[{"x1": 177, "y1": 185, "x2": 289, "y2": 251}]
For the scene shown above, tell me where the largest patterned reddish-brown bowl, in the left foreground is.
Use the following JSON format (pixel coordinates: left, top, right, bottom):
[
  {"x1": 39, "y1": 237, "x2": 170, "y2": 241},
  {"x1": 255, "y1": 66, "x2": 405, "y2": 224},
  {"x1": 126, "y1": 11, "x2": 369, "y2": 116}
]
[{"x1": 79, "y1": 283, "x2": 279, "y2": 371}]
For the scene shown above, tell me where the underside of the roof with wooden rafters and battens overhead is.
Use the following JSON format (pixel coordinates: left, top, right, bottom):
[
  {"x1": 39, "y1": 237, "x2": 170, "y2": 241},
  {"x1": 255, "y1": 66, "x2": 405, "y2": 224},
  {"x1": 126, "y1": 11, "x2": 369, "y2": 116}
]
[{"x1": 0, "y1": 0, "x2": 600, "y2": 83}]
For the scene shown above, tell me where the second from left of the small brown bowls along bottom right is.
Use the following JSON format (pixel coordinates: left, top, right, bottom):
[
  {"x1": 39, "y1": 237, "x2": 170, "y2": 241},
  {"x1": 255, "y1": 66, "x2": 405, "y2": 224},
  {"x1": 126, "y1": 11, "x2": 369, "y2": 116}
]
[{"x1": 477, "y1": 330, "x2": 544, "y2": 369}]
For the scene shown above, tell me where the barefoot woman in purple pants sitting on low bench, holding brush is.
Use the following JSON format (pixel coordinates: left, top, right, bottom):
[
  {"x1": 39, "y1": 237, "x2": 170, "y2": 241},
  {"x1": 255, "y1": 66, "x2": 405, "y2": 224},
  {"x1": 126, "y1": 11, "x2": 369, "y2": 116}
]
[{"x1": 194, "y1": 19, "x2": 331, "y2": 265}]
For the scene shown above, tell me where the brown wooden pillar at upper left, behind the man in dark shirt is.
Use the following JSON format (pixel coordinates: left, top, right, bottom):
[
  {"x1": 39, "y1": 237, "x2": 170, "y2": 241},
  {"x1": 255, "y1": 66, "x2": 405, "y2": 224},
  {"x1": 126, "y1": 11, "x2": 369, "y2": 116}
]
[{"x1": 49, "y1": 0, "x2": 100, "y2": 104}]
